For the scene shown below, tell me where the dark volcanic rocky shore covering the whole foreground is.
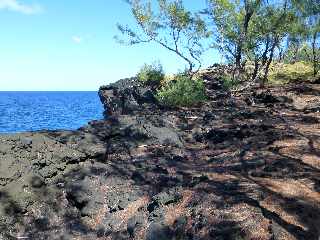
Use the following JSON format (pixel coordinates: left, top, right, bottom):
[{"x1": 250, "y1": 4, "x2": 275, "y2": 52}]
[{"x1": 0, "y1": 70, "x2": 320, "y2": 240}]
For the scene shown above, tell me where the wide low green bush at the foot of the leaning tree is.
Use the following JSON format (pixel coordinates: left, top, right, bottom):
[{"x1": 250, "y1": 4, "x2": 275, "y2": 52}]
[{"x1": 157, "y1": 74, "x2": 206, "y2": 107}]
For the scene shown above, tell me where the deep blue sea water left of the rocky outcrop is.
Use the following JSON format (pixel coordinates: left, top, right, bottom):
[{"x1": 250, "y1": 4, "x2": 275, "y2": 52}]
[{"x1": 0, "y1": 92, "x2": 103, "y2": 133}]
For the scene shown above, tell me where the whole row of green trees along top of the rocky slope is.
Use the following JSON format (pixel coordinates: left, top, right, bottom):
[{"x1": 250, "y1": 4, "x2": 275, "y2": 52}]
[{"x1": 117, "y1": 0, "x2": 320, "y2": 84}]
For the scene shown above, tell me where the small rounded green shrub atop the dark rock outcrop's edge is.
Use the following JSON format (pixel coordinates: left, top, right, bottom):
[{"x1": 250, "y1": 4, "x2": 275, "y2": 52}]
[{"x1": 137, "y1": 63, "x2": 164, "y2": 88}]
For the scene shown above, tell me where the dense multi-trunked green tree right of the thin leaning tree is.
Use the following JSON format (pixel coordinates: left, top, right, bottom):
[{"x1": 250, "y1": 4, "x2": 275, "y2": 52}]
[{"x1": 207, "y1": 0, "x2": 302, "y2": 85}]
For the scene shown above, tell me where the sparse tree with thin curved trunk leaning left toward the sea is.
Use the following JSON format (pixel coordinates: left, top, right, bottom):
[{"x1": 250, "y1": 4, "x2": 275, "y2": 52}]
[{"x1": 117, "y1": 0, "x2": 210, "y2": 74}]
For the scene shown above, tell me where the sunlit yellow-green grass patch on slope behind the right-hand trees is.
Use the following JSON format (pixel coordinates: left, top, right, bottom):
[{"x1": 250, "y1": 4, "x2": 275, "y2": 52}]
[{"x1": 268, "y1": 62, "x2": 314, "y2": 84}]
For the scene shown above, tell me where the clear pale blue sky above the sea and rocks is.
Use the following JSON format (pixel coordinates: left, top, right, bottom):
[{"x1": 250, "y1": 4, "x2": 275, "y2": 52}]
[{"x1": 0, "y1": 0, "x2": 218, "y2": 91}]
